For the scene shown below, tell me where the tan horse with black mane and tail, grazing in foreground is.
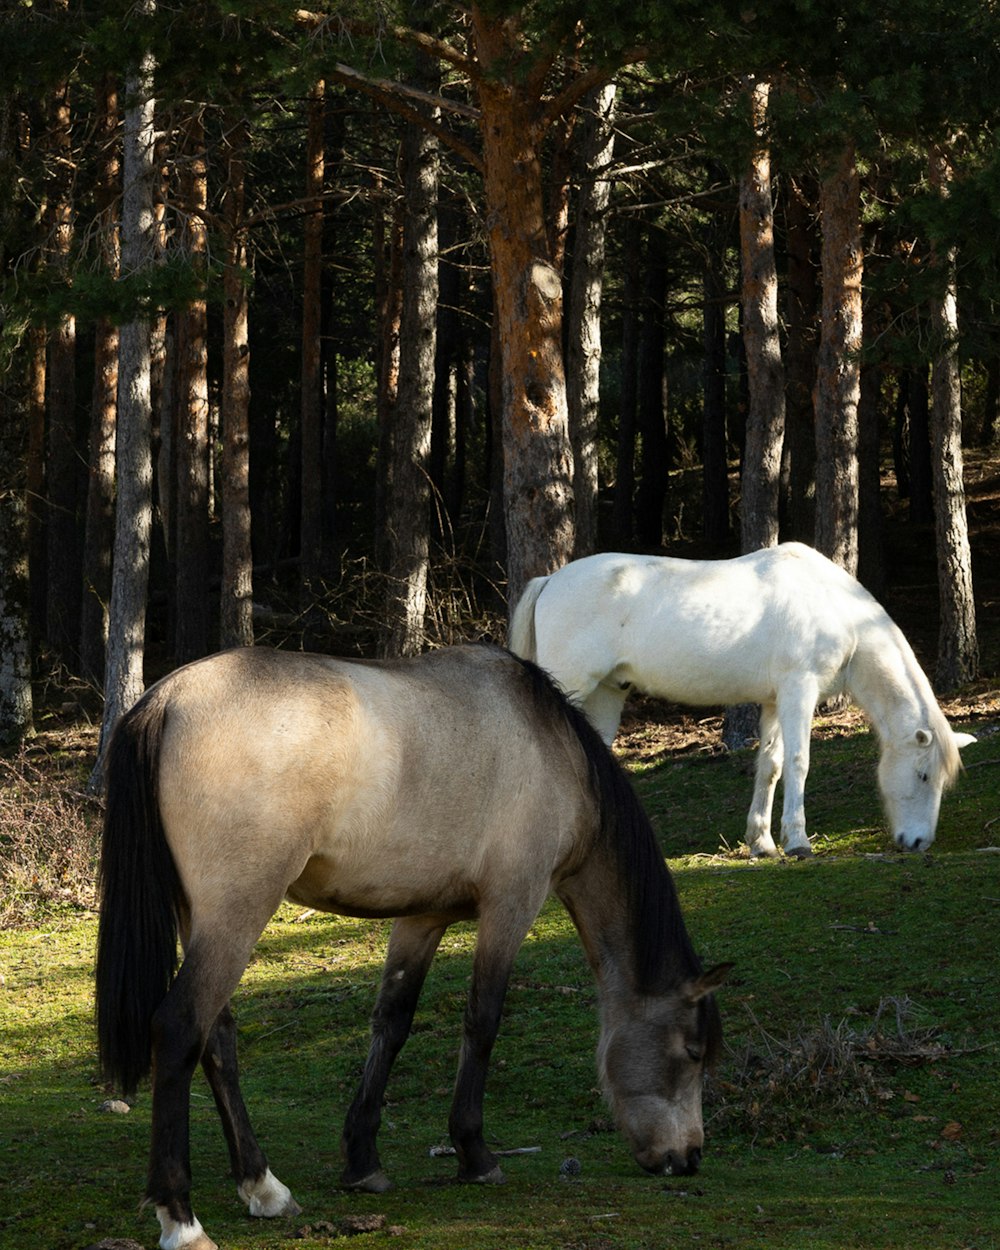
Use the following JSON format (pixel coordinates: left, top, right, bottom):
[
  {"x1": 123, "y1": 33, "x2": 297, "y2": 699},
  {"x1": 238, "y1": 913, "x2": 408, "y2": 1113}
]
[{"x1": 98, "y1": 646, "x2": 729, "y2": 1250}]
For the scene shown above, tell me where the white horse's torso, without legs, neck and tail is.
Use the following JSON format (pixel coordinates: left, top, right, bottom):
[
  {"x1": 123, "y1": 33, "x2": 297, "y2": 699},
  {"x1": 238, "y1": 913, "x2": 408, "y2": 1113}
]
[{"x1": 535, "y1": 544, "x2": 879, "y2": 705}]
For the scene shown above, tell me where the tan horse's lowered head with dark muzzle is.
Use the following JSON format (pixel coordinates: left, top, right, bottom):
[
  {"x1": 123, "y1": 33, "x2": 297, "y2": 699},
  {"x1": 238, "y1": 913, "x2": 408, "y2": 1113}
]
[{"x1": 599, "y1": 964, "x2": 733, "y2": 1176}]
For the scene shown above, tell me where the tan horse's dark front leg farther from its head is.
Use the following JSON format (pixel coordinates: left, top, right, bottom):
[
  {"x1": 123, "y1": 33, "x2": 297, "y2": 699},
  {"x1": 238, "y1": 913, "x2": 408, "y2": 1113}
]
[{"x1": 340, "y1": 918, "x2": 446, "y2": 1193}]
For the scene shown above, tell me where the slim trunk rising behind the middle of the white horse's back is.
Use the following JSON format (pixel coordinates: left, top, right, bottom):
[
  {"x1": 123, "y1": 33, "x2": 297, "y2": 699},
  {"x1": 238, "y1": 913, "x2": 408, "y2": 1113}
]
[{"x1": 740, "y1": 81, "x2": 785, "y2": 551}]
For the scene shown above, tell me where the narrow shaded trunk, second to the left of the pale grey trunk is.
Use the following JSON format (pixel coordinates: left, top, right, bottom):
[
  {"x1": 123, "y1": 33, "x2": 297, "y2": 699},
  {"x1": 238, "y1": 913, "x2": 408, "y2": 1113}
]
[{"x1": 45, "y1": 60, "x2": 83, "y2": 666}]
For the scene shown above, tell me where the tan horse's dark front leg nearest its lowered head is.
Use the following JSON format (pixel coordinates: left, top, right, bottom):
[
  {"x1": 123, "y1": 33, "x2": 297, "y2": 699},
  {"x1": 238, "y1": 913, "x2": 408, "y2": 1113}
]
[{"x1": 449, "y1": 915, "x2": 526, "y2": 1185}]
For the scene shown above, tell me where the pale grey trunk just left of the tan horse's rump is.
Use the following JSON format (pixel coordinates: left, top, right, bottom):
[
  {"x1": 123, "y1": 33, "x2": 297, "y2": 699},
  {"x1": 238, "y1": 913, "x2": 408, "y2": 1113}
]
[{"x1": 91, "y1": 0, "x2": 156, "y2": 789}]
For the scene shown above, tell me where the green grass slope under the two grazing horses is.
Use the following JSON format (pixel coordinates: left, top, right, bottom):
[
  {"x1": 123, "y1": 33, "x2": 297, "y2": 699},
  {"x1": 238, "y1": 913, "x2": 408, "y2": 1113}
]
[{"x1": 0, "y1": 735, "x2": 1000, "y2": 1250}]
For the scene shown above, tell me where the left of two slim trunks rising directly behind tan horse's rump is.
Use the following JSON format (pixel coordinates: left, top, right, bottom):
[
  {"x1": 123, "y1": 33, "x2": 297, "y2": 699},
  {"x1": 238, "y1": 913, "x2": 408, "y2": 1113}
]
[{"x1": 174, "y1": 114, "x2": 210, "y2": 664}]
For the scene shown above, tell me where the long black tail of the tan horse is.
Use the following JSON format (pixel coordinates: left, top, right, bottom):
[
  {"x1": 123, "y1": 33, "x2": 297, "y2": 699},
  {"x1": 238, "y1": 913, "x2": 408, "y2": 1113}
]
[{"x1": 96, "y1": 695, "x2": 183, "y2": 1095}]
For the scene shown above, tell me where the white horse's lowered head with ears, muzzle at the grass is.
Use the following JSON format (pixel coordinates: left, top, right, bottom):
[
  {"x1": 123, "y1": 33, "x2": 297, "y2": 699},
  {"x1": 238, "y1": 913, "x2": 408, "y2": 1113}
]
[{"x1": 879, "y1": 725, "x2": 975, "y2": 851}]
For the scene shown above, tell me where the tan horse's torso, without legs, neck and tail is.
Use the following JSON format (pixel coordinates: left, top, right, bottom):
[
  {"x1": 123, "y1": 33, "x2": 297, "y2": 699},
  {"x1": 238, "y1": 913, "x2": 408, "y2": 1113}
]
[{"x1": 152, "y1": 648, "x2": 583, "y2": 930}]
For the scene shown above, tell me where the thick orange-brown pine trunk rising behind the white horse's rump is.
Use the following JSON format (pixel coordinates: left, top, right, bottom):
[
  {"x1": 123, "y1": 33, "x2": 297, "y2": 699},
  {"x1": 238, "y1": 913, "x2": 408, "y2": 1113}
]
[{"x1": 471, "y1": 5, "x2": 574, "y2": 608}]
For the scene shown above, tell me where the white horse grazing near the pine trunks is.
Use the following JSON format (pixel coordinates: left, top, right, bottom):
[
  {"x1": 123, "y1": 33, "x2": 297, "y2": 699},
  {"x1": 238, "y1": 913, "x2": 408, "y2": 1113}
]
[{"x1": 510, "y1": 543, "x2": 975, "y2": 856}]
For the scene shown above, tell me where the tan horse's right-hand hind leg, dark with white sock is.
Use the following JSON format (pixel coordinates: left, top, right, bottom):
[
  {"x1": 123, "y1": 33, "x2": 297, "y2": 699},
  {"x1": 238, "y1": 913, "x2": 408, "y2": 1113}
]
[{"x1": 201, "y1": 1005, "x2": 301, "y2": 1218}]
